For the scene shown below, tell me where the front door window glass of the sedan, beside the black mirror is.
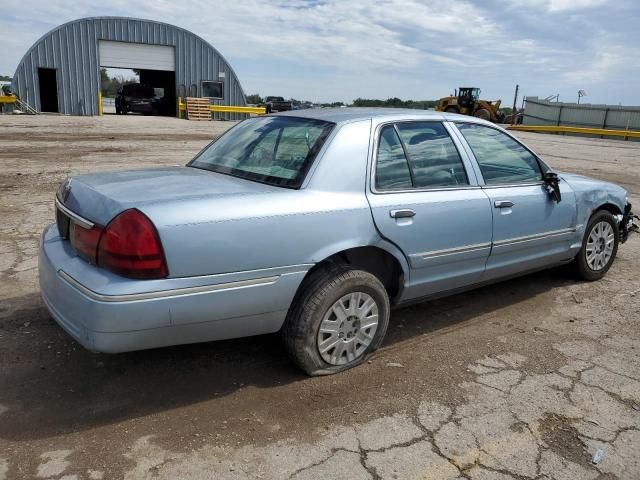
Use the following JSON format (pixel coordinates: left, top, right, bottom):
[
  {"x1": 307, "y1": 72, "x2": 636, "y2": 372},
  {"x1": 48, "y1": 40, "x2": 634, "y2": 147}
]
[{"x1": 457, "y1": 123, "x2": 542, "y2": 185}]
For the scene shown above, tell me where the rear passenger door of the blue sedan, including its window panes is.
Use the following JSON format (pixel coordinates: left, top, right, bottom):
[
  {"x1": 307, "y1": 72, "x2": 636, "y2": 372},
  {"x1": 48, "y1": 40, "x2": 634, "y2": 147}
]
[{"x1": 367, "y1": 121, "x2": 492, "y2": 300}]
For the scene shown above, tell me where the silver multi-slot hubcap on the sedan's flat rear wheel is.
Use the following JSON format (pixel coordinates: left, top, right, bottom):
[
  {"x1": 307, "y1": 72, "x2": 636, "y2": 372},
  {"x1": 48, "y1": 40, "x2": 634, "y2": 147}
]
[{"x1": 318, "y1": 292, "x2": 378, "y2": 365}]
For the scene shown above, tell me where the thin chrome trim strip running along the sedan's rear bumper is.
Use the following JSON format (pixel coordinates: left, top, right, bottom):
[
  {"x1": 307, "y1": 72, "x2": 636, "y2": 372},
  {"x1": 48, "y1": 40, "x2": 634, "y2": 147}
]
[{"x1": 58, "y1": 270, "x2": 280, "y2": 302}]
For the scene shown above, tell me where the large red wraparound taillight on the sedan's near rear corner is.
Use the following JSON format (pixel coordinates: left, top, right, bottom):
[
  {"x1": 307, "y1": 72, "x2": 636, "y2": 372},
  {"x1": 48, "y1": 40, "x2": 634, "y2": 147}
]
[{"x1": 97, "y1": 209, "x2": 168, "y2": 279}]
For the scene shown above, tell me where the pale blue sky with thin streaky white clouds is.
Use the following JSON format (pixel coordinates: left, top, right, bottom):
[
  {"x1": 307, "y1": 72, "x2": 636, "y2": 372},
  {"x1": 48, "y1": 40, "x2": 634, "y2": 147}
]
[{"x1": 0, "y1": 0, "x2": 640, "y2": 105}]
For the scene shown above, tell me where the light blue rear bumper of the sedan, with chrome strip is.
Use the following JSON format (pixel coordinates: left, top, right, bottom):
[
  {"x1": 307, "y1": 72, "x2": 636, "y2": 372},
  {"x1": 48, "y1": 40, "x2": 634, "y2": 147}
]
[{"x1": 38, "y1": 225, "x2": 309, "y2": 353}]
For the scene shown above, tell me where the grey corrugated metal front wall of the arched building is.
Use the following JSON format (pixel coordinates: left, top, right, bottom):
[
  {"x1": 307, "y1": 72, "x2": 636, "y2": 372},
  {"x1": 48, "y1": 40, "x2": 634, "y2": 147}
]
[{"x1": 12, "y1": 17, "x2": 246, "y2": 119}]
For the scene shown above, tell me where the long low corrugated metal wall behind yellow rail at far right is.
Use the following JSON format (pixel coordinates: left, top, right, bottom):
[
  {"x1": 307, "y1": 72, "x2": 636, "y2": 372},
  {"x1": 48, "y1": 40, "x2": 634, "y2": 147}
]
[{"x1": 523, "y1": 97, "x2": 640, "y2": 130}]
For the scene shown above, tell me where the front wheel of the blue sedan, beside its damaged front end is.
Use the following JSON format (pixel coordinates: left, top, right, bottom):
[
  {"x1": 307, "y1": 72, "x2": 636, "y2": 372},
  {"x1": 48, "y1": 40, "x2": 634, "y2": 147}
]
[{"x1": 574, "y1": 210, "x2": 620, "y2": 282}]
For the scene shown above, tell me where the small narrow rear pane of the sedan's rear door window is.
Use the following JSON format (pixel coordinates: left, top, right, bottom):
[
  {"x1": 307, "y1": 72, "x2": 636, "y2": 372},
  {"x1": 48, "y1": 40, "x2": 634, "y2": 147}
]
[{"x1": 376, "y1": 125, "x2": 413, "y2": 190}]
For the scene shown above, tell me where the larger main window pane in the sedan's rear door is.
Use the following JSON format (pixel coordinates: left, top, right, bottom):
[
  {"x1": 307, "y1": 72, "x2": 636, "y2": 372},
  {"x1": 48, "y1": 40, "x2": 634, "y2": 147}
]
[{"x1": 398, "y1": 122, "x2": 469, "y2": 188}]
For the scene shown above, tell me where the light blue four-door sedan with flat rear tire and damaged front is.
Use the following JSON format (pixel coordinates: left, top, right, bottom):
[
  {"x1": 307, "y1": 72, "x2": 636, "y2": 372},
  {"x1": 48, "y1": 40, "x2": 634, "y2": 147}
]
[{"x1": 39, "y1": 108, "x2": 637, "y2": 375}]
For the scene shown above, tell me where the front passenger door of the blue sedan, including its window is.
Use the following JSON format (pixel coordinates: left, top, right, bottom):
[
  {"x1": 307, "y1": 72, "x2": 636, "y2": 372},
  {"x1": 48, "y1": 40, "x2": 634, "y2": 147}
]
[{"x1": 456, "y1": 122, "x2": 576, "y2": 280}]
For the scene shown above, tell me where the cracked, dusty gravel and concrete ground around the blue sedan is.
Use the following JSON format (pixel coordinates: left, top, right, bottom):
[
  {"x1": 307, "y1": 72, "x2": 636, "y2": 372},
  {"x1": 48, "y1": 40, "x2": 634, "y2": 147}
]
[{"x1": 0, "y1": 115, "x2": 640, "y2": 480}]
